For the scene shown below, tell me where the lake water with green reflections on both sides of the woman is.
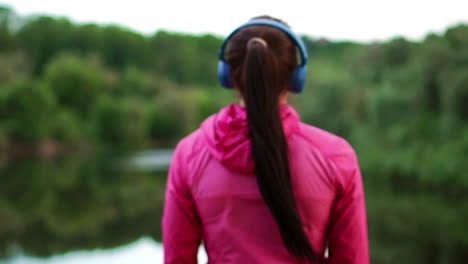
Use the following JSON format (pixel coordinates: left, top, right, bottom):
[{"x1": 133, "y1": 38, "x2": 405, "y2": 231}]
[{"x1": 0, "y1": 151, "x2": 468, "y2": 264}]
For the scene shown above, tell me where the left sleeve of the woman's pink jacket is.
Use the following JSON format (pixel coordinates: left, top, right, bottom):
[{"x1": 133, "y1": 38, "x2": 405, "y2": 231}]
[{"x1": 162, "y1": 142, "x2": 201, "y2": 264}]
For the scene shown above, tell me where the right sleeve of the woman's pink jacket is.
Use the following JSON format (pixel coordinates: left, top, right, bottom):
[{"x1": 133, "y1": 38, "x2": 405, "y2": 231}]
[{"x1": 328, "y1": 139, "x2": 370, "y2": 264}]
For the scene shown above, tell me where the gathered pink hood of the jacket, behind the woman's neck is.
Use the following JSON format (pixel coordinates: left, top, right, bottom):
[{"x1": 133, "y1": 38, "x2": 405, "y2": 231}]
[{"x1": 201, "y1": 104, "x2": 300, "y2": 173}]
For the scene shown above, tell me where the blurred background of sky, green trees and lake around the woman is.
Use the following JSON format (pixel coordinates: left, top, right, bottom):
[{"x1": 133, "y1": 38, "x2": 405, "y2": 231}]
[{"x1": 0, "y1": 1, "x2": 468, "y2": 264}]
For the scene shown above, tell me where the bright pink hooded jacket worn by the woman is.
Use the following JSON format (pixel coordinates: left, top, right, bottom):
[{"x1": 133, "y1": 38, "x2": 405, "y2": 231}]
[{"x1": 162, "y1": 104, "x2": 369, "y2": 264}]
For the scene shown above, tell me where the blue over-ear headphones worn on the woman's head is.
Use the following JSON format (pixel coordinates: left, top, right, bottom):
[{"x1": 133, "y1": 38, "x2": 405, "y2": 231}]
[{"x1": 218, "y1": 18, "x2": 308, "y2": 93}]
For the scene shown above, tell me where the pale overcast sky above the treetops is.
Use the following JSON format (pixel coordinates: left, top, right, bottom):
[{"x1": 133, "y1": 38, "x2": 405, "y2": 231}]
[{"x1": 0, "y1": 0, "x2": 468, "y2": 41}]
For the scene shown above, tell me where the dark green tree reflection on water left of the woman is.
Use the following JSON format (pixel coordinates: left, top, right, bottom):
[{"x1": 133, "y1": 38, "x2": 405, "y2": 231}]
[{"x1": 0, "y1": 156, "x2": 166, "y2": 256}]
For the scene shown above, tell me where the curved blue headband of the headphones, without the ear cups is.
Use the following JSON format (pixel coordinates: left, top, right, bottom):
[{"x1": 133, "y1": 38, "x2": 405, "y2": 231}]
[{"x1": 219, "y1": 18, "x2": 308, "y2": 66}]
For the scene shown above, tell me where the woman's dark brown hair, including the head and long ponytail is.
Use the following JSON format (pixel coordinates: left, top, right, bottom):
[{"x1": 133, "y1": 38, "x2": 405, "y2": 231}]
[{"x1": 226, "y1": 16, "x2": 321, "y2": 263}]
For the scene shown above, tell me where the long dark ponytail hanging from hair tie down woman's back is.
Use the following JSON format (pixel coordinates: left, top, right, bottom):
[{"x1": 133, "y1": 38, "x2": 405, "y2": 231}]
[{"x1": 239, "y1": 37, "x2": 321, "y2": 263}]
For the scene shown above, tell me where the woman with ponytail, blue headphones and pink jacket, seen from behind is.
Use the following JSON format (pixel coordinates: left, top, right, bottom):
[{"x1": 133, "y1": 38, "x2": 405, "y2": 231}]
[{"x1": 162, "y1": 17, "x2": 369, "y2": 264}]
